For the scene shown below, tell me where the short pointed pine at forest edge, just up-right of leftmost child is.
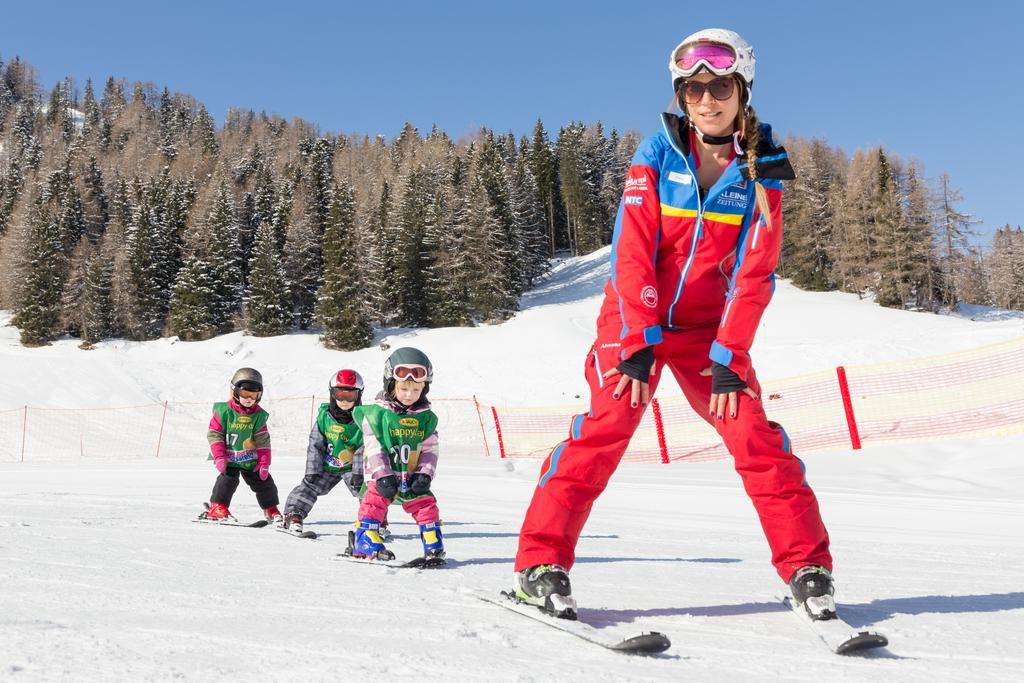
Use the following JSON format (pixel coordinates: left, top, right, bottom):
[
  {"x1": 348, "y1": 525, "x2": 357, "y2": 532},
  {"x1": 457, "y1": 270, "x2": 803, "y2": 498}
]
[{"x1": 245, "y1": 223, "x2": 292, "y2": 337}]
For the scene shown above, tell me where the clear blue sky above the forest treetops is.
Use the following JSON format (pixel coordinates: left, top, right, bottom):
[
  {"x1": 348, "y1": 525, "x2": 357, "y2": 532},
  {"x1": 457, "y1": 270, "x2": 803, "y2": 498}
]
[{"x1": 0, "y1": 0, "x2": 1024, "y2": 239}]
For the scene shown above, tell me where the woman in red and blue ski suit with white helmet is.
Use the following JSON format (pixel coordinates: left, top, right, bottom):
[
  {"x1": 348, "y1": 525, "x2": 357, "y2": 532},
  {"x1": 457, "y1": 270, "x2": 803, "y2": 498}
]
[{"x1": 515, "y1": 29, "x2": 834, "y2": 618}]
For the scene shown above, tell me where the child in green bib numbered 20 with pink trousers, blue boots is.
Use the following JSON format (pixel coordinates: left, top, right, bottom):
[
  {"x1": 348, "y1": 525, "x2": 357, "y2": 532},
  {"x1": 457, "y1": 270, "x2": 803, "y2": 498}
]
[{"x1": 347, "y1": 347, "x2": 444, "y2": 566}]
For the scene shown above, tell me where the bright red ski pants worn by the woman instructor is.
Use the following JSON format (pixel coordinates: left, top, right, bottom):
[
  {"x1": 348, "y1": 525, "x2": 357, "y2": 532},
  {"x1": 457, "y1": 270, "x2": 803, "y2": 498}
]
[{"x1": 515, "y1": 329, "x2": 831, "y2": 581}]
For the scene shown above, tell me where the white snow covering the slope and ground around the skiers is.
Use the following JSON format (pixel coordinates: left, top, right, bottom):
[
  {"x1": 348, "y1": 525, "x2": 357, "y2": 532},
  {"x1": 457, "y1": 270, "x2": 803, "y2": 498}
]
[{"x1": 0, "y1": 253, "x2": 1024, "y2": 683}]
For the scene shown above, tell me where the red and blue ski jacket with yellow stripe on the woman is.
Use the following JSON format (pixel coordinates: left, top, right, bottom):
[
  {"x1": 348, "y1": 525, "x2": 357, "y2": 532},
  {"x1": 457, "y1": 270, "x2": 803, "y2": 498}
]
[{"x1": 598, "y1": 109, "x2": 795, "y2": 381}]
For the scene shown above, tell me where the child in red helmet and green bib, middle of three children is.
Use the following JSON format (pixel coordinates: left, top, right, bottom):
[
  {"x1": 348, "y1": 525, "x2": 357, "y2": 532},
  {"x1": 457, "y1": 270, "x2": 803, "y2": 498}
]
[{"x1": 285, "y1": 370, "x2": 362, "y2": 533}]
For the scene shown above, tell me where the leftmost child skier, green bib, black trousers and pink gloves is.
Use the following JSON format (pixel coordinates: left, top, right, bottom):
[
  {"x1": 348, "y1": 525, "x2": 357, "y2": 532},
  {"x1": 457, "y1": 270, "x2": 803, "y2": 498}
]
[{"x1": 200, "y1": 368, "x2": 282, "y2": 522}]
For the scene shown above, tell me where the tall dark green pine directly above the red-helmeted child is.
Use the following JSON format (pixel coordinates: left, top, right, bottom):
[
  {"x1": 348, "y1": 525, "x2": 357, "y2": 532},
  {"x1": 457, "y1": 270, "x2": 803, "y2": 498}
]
[{"x1": 316, "y1": 182, "x2": 373, "y2": 351}]
